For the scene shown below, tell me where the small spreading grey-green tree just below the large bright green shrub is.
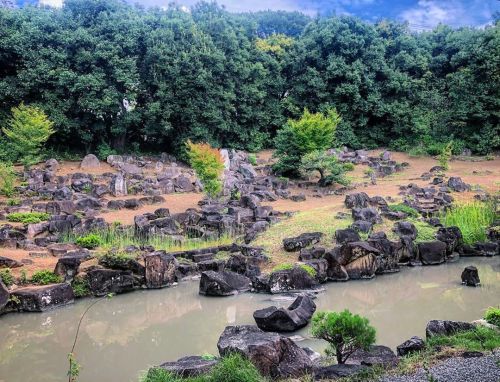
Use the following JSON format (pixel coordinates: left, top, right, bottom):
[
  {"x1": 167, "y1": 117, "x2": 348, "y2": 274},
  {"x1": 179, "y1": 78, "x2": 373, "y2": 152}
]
[{"x1": 300, "y1": 151, "x2": 349, "y2": 186}]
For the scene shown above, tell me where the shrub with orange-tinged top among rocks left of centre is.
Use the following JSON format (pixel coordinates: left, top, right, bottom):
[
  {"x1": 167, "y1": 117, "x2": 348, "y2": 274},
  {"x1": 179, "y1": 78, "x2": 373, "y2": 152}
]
[{"x1": 186, "y1": 141, "x2": 224, "y2": 198}]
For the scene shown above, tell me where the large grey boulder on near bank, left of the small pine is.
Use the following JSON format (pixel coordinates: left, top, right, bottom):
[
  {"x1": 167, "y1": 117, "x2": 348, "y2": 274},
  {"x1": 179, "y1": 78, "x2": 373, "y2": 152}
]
[{"x1": 217, "y1": 325, "x2": 312, "y2": 378}]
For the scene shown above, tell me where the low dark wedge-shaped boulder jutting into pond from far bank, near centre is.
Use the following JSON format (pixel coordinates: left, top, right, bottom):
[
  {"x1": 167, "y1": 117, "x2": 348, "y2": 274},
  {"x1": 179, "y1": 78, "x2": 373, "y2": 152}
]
[{"x1": 199, "y1": 271, "x2": 251, "y2": 296}]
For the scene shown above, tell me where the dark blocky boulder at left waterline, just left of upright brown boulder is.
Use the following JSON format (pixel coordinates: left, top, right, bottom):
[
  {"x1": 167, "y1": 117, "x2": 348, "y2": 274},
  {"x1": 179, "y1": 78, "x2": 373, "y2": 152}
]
[{"x1": 87, "y1": 269, "x2": 134, "y2": 297}]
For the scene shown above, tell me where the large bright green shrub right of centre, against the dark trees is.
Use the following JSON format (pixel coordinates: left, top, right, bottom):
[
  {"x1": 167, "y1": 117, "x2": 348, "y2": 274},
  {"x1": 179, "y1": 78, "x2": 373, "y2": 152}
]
[{"x1": 274, "y1": 109, "x2": 341, "y2": 176}]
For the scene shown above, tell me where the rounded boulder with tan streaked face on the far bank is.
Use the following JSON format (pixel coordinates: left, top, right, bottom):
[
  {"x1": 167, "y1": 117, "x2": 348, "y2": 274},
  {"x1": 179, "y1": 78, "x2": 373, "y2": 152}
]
[{"x1": 338, "y1": 241, "x2": 380, "y2": 280}]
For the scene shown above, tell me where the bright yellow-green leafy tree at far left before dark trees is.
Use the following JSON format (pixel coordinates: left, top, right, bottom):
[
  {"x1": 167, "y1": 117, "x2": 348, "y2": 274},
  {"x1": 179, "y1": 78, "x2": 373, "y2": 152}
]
[{"x1": 2, "y1": 103, "x2": 55, "y2": 166}]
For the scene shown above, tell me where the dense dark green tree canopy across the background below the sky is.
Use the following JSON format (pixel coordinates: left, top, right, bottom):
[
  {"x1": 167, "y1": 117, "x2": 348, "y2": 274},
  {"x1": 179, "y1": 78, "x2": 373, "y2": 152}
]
[{"x1": 0, "y1": 0, "x2": 500, "y2": 153}]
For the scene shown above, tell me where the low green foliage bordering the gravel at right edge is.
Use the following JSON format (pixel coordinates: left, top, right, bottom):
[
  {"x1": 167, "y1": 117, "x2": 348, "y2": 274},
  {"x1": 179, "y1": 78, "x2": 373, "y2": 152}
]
[{"x1": 426, "y1": 326, "x2": 500, "y2": 351}]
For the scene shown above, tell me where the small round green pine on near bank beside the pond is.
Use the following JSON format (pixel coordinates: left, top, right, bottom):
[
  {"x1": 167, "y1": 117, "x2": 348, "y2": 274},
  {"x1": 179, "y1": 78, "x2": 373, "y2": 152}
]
[{"x1": 311, "y1": 309, "x2": 375, "y2": 364}]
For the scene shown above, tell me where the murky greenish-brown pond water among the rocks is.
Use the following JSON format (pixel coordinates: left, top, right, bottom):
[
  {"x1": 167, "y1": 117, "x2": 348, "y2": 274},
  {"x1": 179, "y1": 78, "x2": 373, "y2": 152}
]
[{"x1": 0, "y1": 257, "x2": 500, "y2": 382}]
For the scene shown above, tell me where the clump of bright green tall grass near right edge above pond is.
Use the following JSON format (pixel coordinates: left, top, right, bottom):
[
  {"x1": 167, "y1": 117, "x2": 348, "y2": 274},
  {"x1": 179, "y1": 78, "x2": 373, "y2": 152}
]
[{"x1": 440, "y1": 201, "x2": 496, "y2": 244}]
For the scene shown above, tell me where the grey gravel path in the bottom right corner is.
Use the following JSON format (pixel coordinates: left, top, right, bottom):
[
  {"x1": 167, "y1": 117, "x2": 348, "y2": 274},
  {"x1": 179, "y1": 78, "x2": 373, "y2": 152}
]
[{"x1": 379, "y1": 352, "x2": 500, "y2": 382}]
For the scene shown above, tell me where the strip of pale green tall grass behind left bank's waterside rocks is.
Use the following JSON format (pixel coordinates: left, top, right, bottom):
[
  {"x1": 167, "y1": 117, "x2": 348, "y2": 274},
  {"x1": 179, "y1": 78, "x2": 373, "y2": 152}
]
[{"x1": 62, "y1": 226, "x2": 237, "y2": 252}]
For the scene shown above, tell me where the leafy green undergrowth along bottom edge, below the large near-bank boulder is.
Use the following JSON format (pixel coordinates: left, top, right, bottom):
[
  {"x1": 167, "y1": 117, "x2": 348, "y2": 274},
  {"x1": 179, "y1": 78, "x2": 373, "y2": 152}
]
[{"x1": 140, "y1": 354, "x2": 268, "y2": 382}]
